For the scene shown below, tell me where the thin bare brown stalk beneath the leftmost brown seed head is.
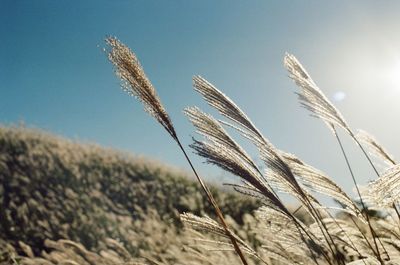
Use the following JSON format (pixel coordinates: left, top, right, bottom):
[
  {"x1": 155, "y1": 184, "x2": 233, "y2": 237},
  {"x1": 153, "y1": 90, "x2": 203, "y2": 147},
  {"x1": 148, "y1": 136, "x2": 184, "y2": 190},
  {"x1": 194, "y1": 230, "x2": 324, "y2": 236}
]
[{"x1": 176, "y1": 137, "x2": 248, "y2": 265}]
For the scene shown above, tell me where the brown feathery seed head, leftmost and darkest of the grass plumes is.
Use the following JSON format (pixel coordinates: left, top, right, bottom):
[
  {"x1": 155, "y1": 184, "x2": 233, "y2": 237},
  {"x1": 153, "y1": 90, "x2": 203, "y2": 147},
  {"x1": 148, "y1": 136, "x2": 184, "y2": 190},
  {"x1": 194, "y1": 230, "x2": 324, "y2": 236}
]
[{"x1": 105, "y1": 37, "x2": 177, "y2": 140}]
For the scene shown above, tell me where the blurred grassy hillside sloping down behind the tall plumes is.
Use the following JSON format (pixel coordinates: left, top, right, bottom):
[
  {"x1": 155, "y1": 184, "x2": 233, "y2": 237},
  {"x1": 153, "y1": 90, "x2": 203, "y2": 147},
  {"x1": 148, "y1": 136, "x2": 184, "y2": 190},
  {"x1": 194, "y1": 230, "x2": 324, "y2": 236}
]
[{"x1": 0, "y1": 127, "x2": 257, "y2": 264}]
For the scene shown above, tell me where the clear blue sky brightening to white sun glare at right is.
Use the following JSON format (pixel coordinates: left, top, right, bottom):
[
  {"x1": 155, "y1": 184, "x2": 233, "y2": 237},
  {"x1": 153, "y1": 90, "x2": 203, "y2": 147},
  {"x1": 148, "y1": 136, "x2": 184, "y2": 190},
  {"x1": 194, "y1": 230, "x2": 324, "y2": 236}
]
[{"x1": 0, "y1": 0, "x2": 400, "y2": 194}]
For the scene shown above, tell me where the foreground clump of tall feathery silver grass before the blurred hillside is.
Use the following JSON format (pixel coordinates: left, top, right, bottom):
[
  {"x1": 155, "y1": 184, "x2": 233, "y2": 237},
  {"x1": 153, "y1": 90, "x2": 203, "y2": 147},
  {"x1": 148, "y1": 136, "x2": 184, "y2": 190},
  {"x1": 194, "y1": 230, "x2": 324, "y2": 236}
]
[{"x1": 106, "y1": 38, "x2": 400, "y2": 265}]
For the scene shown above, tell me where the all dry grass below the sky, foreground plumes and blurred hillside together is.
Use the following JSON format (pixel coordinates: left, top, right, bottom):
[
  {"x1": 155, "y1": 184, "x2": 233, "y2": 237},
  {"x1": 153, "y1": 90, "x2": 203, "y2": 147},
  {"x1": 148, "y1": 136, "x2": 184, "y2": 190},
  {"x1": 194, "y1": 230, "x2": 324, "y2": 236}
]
[{"x1": 0, "y1": 38, "x2": 400, "y2": 265}]
